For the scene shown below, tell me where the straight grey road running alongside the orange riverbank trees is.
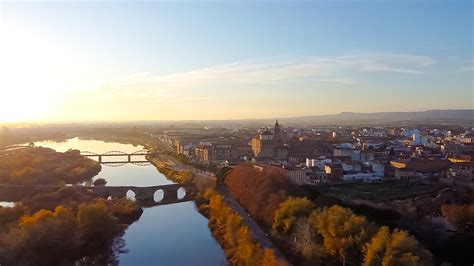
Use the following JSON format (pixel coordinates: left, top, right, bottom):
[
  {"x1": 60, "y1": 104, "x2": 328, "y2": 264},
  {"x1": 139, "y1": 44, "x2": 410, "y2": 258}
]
[{"x1": 217, "y1": 188, "x2": 290, "y2": 265}]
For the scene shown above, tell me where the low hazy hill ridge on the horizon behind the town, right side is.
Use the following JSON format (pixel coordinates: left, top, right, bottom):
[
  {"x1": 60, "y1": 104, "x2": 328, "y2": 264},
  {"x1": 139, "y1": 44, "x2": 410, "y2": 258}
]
[{"x1": 280, "y1": 109, "x2": 474, "y2": 124}]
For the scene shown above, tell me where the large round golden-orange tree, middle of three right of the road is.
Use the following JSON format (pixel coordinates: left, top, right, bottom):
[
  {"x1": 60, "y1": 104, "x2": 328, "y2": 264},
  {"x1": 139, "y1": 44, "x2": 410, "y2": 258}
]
[{"x1": 310, "y1": 205, "x2": 375, "y2": 265}]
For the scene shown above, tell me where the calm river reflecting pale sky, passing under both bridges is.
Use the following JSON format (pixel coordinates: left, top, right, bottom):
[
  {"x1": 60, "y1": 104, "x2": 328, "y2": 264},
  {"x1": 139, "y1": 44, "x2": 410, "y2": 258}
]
[{"x1": 35, "y1": 138, "x2": 227, "y2": 266}]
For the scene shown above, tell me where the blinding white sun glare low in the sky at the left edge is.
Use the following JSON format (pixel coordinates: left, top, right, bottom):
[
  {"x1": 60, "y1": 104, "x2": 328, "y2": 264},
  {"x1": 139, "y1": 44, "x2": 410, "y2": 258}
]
[{"x1": 0, "y1": 24, "x2": 82, "y2": 122}]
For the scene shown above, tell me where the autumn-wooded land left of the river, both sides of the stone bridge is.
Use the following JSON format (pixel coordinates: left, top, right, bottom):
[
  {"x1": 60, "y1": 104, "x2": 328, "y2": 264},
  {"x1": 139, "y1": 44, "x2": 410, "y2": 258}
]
[{"x1": 0, "y1": 147, "x2": 143, "y2": 265}]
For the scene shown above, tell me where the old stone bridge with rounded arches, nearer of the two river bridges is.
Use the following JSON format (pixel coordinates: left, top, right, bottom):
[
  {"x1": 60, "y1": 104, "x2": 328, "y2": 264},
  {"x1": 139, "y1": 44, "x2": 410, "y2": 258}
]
[{"x1": 0, "y1": 184, "x2": 197, "y2": 207}]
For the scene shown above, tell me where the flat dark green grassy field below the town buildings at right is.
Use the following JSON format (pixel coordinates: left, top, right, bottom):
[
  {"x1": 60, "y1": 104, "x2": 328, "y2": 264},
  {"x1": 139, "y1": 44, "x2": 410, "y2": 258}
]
[{"x1": 315, "y1": 181, "x2": 445, "y2": 202}]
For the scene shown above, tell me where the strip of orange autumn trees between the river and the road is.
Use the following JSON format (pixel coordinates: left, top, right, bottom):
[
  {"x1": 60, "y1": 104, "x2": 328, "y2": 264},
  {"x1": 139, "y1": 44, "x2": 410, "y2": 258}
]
[{"x1": 147, "y1": 155, "x2": 289, "y2": 266}]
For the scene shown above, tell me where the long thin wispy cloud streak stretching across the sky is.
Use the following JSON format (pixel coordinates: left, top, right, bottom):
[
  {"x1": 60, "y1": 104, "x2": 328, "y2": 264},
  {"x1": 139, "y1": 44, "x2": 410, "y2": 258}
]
[{"x1": 102, "y1": 53, "x2": 435, "y2": 102}]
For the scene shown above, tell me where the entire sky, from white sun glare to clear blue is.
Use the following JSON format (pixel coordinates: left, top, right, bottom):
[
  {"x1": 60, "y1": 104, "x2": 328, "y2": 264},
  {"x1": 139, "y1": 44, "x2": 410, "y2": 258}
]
[{"x1": 0, "y1": 0, "x2": 474, "y2": 122}]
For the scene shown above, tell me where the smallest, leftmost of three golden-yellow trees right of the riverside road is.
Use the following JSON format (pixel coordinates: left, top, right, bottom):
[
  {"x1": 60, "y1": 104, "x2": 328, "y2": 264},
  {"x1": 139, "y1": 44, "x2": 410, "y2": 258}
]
[{"x1": 272, "y1": 197, "x2": 314, "y2": 234}]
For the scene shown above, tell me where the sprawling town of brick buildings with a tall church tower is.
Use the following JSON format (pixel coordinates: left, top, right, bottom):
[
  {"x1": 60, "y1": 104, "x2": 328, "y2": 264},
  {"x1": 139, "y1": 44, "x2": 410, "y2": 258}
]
[{"x1": 152, "y1": 121, "x2": 474, "y2": 187}]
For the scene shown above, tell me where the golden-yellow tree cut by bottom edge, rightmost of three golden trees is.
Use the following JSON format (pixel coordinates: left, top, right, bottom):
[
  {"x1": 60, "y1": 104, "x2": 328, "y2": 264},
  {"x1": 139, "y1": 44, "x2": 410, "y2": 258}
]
[{"x1": 364, "y1": 226, "x2": 433, "y2": 266}]
